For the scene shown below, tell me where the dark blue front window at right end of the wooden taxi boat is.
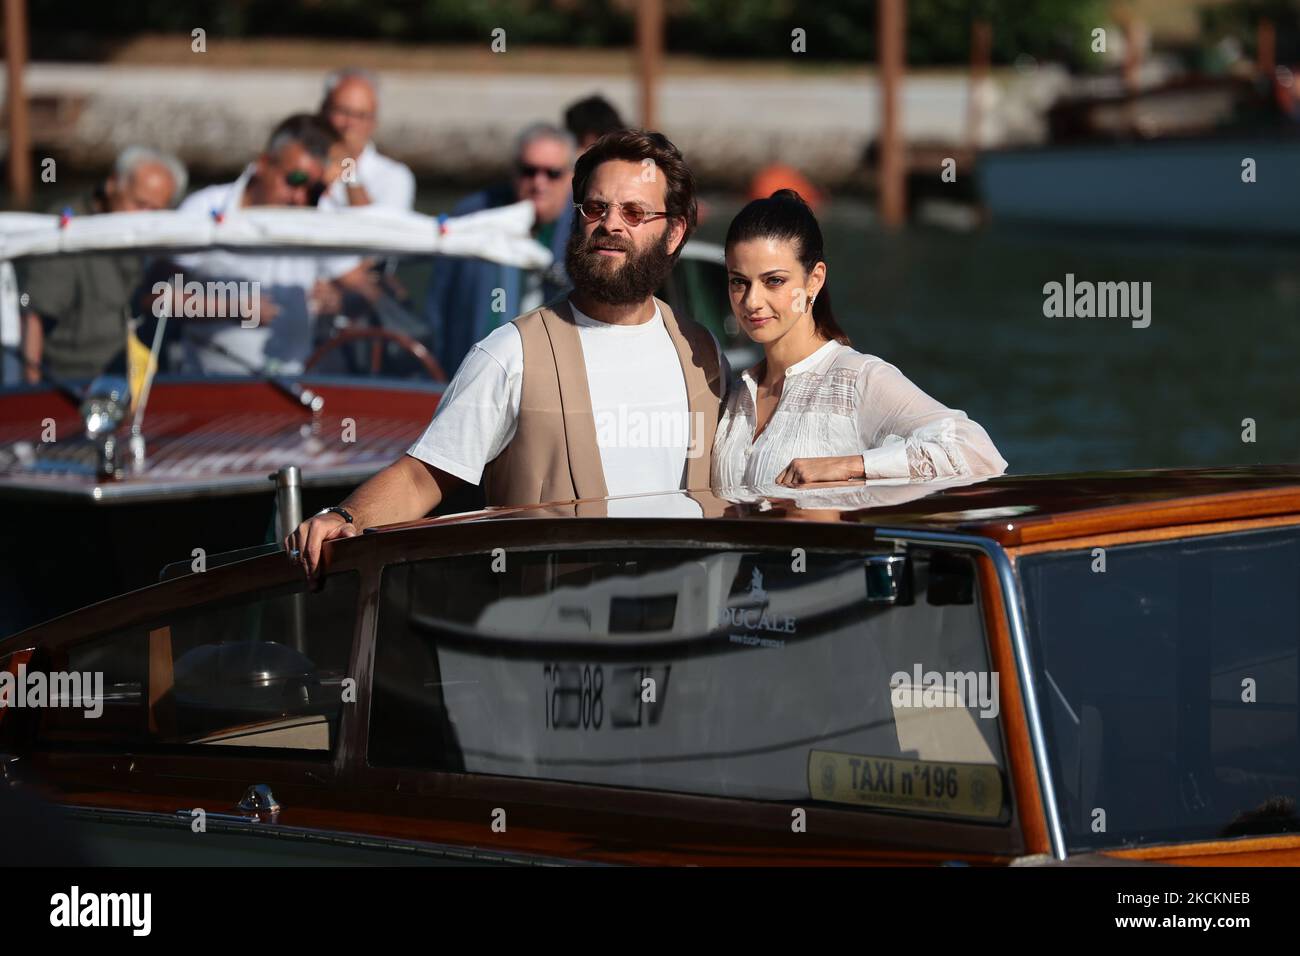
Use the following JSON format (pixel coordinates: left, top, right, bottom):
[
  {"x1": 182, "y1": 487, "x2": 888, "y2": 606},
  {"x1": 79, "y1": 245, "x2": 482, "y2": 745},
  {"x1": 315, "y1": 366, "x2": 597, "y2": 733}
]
[{"x1": 1019, "y1": 528, "x2": 1300, "y2": 851}]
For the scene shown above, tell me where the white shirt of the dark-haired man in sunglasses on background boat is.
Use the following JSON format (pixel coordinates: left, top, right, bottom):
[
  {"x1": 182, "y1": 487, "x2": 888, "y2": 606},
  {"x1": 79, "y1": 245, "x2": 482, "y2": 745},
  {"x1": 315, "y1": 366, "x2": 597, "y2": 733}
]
[{"x1": 174, "y1": 165, "x2": 348, "y2": 375}]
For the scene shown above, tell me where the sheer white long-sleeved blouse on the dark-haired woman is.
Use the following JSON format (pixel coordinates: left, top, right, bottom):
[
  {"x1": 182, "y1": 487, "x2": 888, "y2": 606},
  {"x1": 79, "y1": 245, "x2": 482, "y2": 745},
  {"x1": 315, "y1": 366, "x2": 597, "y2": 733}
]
[{"x1": 712, "y1": 342, "x2": 1006, "y2": 488}]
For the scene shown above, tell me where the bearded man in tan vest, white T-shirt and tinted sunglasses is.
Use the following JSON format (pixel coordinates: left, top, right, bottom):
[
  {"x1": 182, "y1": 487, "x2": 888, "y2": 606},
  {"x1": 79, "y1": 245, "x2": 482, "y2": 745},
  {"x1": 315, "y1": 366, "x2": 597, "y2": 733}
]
[{"x1": 285, "y1": 130, "x2": 728, "y2": 576}]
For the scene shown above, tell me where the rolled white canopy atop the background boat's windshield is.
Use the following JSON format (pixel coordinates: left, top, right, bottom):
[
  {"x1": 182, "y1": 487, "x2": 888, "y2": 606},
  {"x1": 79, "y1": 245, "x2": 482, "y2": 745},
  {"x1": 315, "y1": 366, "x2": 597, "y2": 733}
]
[{"x1": 0, "y1": 200, "x2": 553, "y2": 269}]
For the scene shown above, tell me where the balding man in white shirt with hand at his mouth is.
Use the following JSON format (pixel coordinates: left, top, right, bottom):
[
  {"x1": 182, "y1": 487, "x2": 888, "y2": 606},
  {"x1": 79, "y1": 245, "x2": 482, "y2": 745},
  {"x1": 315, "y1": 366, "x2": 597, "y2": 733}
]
[{"x1": 321, "y1": 69, "x2": 415, "y2": 209}]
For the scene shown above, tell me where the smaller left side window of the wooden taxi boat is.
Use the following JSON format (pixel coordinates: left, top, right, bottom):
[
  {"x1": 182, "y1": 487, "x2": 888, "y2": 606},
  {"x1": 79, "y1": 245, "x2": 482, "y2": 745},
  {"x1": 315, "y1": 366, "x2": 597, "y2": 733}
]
[{"x1": 27, "y1": 572, "x2": 360, "y2": 760}]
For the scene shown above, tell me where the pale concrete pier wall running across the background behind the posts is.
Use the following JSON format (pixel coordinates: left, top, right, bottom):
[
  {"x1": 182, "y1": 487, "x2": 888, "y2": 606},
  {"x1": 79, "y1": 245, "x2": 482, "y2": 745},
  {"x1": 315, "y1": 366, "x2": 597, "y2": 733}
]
[{"x1": 5, "y1": 62, "x2": 1066, "y2": 187}]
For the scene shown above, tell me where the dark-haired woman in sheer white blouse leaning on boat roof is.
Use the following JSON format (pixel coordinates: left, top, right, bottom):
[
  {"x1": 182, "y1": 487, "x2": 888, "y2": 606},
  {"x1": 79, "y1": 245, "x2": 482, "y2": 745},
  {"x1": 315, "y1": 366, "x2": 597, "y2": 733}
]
[{"x1": 712, "y1": 190, "x2": 1006, "y2": 488}]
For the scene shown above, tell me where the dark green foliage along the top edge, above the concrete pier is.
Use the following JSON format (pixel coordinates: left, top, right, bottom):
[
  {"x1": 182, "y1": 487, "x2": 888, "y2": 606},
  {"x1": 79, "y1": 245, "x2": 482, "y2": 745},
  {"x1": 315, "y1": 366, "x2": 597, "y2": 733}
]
[{"x1": 30, "y1": 0, "x2": 1106, "y2": 66}]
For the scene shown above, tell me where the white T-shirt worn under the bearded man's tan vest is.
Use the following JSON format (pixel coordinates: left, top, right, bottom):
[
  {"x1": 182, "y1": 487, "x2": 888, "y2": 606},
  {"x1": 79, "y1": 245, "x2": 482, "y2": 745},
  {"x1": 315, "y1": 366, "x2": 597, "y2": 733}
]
[{"x1": 408, "y1": 302, "x2": 716, "y2": 516}]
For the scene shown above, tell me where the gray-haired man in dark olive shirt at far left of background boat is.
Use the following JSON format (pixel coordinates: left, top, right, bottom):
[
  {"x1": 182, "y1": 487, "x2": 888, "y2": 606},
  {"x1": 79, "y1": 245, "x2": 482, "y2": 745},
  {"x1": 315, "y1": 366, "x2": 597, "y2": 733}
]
[{"x1": 18, "y1": 146, "x2": 187, "y2": 384}]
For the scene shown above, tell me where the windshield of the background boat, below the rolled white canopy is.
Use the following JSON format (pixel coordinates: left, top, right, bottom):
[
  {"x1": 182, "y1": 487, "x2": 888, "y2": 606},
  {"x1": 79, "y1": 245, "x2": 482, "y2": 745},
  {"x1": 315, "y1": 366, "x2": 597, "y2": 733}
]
[{"x1": 0, "y1": 248, "x2": 740, "y2": 390}]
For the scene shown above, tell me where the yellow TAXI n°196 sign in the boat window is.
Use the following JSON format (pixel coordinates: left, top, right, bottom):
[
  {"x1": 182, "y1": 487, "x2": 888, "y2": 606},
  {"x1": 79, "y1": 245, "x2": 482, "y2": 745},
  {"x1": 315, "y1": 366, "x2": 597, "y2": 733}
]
[{"x1": 809, "y1": 750, "x2": 1002, "y2": 819}]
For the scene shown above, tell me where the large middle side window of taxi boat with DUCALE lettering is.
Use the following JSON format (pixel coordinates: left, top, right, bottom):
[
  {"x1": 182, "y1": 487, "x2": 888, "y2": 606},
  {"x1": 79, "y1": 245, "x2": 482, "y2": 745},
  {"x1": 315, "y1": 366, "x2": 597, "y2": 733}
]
[{"x1": 369, "y1": 546, "x2": 1009, "y2": 822}]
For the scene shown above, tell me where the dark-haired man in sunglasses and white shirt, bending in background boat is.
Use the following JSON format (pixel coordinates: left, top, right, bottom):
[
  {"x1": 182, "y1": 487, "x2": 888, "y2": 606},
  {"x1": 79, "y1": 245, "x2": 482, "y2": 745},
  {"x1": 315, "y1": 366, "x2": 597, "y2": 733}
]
[{"x1": 167, "y1": 113, "x2": 367, "y2": 375}]
